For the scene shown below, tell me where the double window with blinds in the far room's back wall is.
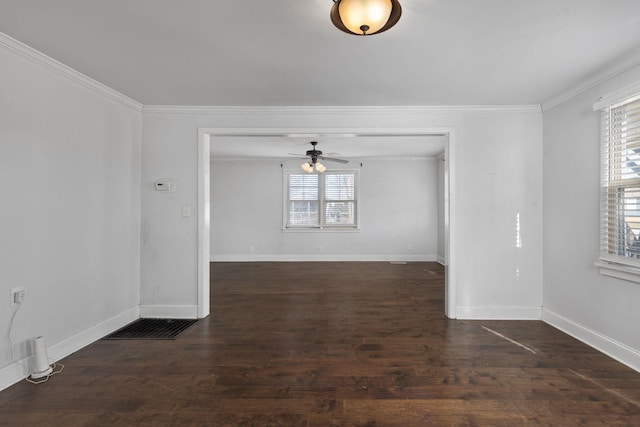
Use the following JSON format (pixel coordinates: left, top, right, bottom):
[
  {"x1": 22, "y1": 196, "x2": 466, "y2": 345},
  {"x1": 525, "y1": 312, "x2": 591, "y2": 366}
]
[{"x1": 284, "y1": 171, "x2": 358, "y2": 229}]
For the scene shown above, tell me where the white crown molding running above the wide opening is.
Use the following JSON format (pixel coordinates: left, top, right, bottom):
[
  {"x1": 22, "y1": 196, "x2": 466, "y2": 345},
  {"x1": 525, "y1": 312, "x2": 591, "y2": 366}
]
[{"x1": 142, "y1": 105, "x2": 541, "y2": 115}]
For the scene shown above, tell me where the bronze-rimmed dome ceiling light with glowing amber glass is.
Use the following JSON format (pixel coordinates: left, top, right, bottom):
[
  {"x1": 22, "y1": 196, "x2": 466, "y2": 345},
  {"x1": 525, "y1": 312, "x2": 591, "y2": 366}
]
[{"x1": 331, "y1": 0, "x2": 402, "y2": 36}]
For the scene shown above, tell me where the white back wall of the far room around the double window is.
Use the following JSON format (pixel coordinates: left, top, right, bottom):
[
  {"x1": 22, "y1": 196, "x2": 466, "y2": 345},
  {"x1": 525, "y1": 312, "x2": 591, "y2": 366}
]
[{"x1": 210, "y1": 158, "x2": 437, "y2": 261}]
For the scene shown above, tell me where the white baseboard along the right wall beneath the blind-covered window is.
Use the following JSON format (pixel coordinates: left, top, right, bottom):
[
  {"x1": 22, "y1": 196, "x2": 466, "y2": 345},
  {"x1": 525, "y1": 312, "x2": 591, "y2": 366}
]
[{"x1": 542, "y1": 308, "x2": 640, "y2": 372}]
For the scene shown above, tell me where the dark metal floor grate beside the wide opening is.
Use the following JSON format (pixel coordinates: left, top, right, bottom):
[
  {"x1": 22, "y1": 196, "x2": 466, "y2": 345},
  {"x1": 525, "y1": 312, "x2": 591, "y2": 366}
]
[{"x1": 103, "y1": 319, "x2": 197, "y2": 340}]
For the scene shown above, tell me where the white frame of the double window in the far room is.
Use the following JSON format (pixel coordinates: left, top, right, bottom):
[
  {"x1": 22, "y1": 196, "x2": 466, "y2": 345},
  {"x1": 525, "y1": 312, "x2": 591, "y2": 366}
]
[{"x1": 282, "y1": 169, "x2": 360, "y2": 232}]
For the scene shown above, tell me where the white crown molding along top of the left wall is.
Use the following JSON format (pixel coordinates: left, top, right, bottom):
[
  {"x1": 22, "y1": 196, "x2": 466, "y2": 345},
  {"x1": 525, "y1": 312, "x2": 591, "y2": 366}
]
[{"x1": 0, "y1": 32, "x2": 142, "y2": 112}]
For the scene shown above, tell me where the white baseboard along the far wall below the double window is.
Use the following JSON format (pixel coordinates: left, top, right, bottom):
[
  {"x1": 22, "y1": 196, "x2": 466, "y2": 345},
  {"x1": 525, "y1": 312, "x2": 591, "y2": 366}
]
[{"x1": 210, "y1": 254, "x2": 438, "y2": 262}]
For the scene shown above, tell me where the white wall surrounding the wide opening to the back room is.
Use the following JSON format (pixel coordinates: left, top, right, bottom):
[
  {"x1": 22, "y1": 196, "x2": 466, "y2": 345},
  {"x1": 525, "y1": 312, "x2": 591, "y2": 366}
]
[{"x1": 141, "y1": 106, "x2": 542, "y2": 318}]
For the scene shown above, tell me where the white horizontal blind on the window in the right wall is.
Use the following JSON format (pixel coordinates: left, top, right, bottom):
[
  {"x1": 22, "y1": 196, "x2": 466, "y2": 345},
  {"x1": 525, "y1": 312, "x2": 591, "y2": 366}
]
[{"x1": 600, "y1": 95, "x2": 640, "y2": 264}]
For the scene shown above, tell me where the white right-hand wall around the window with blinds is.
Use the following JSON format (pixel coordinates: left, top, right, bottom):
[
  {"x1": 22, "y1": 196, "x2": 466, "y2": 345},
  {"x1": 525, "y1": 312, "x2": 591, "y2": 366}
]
[{"x1": 544, "y1": 67, "x2": 640, "y2": 370}]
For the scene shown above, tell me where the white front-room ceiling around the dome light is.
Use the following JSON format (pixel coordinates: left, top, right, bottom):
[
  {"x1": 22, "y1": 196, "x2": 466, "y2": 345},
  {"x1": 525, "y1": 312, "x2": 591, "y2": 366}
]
[{"x1": 0, "y1": 0, "x2": 640, "y2": 156}]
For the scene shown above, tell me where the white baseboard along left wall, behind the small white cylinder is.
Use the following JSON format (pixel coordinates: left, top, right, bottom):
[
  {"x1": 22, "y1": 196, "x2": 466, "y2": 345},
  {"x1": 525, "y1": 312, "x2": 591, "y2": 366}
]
[{"x1": 0, "y1": 306, "x2": 140, "y2": 390}]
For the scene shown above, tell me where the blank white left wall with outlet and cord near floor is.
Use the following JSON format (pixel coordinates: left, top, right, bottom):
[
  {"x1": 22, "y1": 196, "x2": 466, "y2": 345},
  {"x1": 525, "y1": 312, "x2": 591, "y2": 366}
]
[{"x1": 0, "y1": 34, "x2": 141, "y2": 389}]
